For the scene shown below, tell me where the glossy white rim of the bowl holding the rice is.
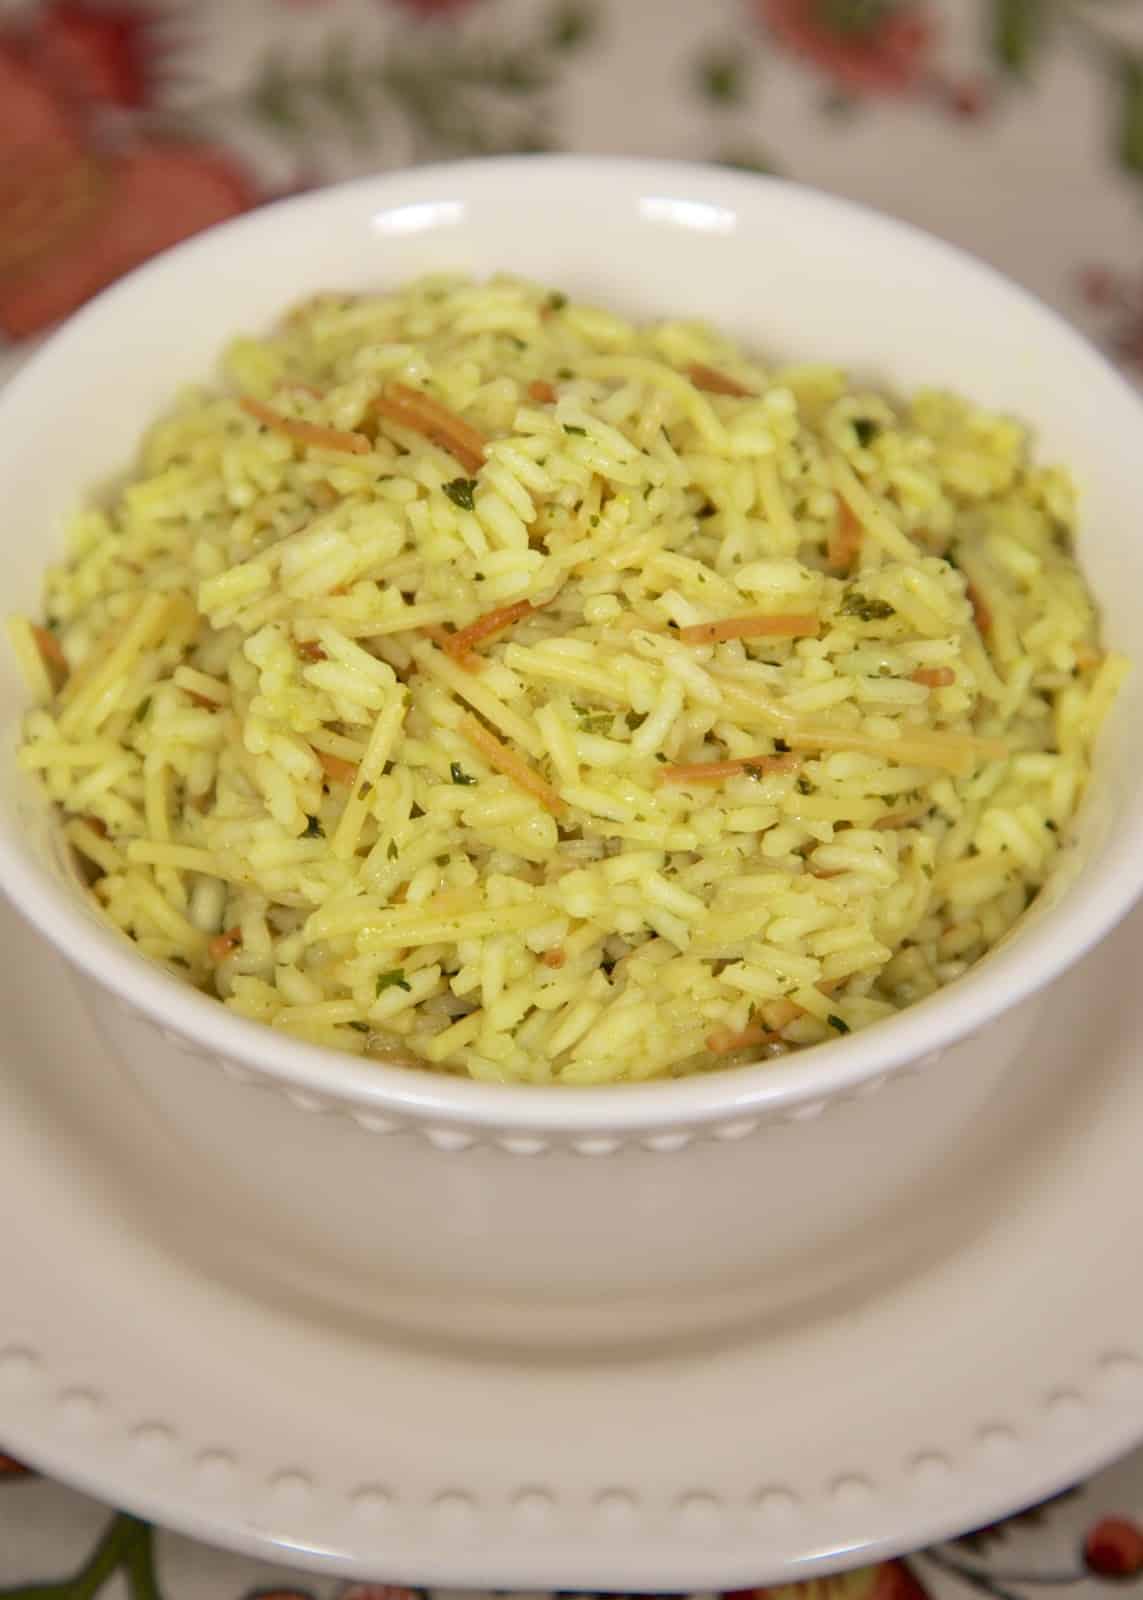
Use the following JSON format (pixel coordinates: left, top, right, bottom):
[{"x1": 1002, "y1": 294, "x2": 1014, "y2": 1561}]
[{"x1": 0, "y1": 155, "x2": 1143, "y2": 1134}]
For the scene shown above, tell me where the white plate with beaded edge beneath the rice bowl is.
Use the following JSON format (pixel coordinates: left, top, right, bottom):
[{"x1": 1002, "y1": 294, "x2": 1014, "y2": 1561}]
[{"x1": 0, "y1": 907, "x2": 1143, "y2": 1590}]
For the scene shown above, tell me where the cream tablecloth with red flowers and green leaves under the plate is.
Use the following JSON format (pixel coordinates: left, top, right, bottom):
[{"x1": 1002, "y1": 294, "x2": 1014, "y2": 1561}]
[{"x1": 0, "y1": 0, "x2": 1143, "y2": 1600}]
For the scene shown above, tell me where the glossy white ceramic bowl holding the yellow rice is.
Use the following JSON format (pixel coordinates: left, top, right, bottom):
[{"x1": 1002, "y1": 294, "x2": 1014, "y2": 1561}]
[{"x1": 0, "y1": 158, "x2": 1143, "y2": 1339}]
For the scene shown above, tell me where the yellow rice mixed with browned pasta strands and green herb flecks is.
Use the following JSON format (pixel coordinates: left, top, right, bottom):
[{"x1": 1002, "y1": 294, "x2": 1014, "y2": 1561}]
[{"x1": 11, "y1": 278, "x2": 1124, "y2": 1083}]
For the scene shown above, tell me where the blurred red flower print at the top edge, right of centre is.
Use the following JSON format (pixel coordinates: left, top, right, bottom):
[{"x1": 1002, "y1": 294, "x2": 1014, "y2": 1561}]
[{"x1": 754, "y1": 0, "x2": 935, "y2": 94}]
